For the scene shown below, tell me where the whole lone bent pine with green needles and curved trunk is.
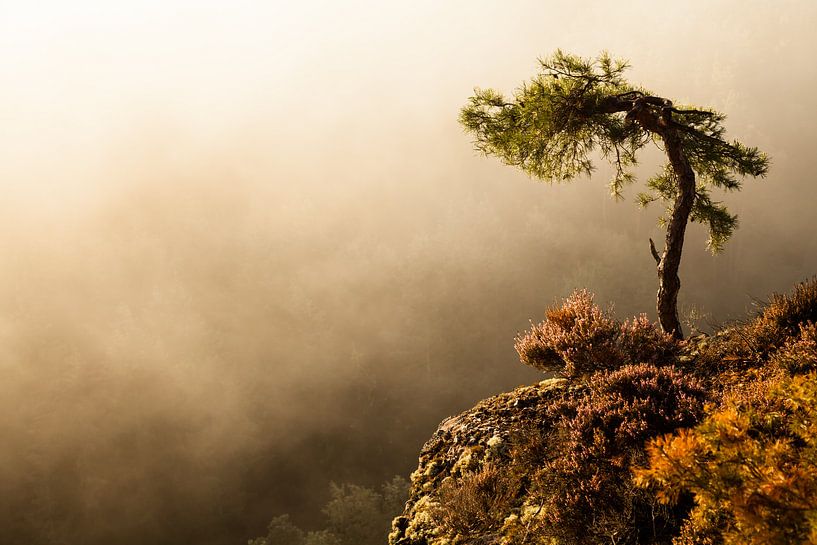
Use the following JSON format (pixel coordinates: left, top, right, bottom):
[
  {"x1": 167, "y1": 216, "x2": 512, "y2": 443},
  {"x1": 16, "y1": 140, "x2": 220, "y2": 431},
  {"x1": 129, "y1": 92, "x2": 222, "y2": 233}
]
[{"x1": 459, "y1": 50, "x2": 769, "y2": 338}]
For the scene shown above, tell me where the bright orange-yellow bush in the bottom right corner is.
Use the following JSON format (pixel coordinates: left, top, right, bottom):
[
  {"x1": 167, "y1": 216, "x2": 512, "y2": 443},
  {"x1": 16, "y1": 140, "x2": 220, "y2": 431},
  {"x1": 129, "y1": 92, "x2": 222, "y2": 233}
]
[{"x1": 636, "y1": 373, "x2": 817, "y2": 545}]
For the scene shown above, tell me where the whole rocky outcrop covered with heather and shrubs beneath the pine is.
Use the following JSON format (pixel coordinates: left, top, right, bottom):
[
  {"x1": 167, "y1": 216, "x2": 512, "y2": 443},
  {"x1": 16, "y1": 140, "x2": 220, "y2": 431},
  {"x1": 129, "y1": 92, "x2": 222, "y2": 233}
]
[{"x1": 389, "y1": 280, "x2": 817, "y2": 545}]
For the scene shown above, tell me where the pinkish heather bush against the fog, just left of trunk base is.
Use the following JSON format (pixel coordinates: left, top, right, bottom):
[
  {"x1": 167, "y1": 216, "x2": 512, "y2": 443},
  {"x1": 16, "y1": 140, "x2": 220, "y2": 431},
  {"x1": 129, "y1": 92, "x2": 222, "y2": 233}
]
[{"x1": 515, "y1": 290, "x2": 679, "y2": 378}]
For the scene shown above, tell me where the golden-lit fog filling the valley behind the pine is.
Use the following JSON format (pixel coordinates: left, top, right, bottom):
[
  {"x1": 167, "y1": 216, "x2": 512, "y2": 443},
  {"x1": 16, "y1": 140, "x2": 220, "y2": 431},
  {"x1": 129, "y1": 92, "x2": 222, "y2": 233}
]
[{"x1": 0, "y1": 0, "x2": 817, "y2": 545}]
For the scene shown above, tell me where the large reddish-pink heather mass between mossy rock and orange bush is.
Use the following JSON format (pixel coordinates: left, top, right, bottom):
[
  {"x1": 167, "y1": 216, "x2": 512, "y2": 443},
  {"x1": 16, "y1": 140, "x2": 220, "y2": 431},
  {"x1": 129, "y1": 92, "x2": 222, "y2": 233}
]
[{"x1": 531, "y1": 364, "x2": 705, "y2": 544}]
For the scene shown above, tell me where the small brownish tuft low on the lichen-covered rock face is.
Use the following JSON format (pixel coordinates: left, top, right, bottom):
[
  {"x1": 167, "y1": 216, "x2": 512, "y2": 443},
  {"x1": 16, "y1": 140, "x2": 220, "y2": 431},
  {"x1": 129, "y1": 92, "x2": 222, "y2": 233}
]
[{"x1": 434, "y1": 464, "x2": 521, "y2": 536}]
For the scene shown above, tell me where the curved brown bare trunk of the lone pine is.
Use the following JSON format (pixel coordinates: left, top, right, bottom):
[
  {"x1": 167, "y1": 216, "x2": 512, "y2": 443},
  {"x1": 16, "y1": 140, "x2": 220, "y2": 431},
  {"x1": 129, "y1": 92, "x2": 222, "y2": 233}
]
[{"x1": 657, "y1": 128, "x2": 695, "y2": 339}]
